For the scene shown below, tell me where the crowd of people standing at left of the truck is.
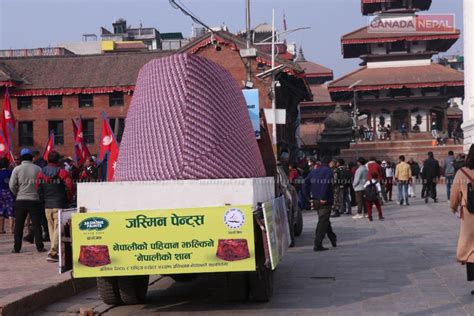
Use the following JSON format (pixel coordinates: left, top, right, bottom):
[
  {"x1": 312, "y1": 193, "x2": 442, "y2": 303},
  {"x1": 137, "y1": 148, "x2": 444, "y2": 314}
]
[{"x1": 0, "y1": 148, "x2": 100, "y2": 262}]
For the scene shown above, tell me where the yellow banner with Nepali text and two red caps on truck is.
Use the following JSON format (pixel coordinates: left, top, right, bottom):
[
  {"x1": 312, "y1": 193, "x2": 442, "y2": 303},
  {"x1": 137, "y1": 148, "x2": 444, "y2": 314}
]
[{"x1": 72, "y1": 206, "x2": 255, "y2": 278}]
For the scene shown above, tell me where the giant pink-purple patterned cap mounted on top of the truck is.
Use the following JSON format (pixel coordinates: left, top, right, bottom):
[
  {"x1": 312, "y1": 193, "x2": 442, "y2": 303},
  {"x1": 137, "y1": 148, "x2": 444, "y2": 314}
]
[{"x1": 114, "y1": 54, "x2": 265, "y2": 181}]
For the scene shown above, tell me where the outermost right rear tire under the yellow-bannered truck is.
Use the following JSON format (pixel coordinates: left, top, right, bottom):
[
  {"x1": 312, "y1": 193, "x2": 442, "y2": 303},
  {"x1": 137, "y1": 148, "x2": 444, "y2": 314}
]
[{"x1": 248, "y1": 266, "x2": 273, "y2": 302}]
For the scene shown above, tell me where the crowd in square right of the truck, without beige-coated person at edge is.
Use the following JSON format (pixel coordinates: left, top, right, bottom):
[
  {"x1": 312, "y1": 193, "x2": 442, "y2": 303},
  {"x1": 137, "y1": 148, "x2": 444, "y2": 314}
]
[{"x1": 289, "y1": 151, "x2": 466, "y2": 251}]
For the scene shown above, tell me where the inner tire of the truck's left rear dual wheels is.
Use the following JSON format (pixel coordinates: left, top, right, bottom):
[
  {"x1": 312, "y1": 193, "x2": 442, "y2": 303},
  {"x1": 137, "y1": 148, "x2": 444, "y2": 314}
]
[{"x1": 117, "y1": 275, "x2": 150, "y2": 305}]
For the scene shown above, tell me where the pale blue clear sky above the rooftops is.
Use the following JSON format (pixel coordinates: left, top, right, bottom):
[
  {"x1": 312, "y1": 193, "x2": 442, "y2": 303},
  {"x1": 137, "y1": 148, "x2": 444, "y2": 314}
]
[{"x1": 0, "y1": 0, "x2": 463, "y2": 77}]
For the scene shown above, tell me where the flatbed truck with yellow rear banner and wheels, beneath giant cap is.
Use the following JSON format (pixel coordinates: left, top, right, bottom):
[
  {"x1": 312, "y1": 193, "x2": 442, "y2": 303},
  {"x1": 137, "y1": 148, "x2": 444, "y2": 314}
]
[{"x1": 72, "y1": 178, "x2": 291, "y2": 305}]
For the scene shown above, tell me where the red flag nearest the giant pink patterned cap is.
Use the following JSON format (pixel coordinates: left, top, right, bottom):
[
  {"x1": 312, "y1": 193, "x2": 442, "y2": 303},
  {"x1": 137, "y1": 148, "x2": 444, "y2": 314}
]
[{"x1": 99, "y1": 113, "x2": 119, "y2": 181}]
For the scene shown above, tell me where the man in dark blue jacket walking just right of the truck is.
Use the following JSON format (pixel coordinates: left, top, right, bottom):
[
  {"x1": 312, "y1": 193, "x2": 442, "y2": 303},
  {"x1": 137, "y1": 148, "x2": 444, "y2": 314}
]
[{"x1": 303, "y1": 158, "x2": 337, "y2": 251}]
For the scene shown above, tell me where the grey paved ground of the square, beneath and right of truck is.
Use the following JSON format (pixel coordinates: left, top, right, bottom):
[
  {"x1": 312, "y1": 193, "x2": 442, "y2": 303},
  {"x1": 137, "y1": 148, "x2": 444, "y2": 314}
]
[{"x1": 37, "y1": 185, "x2": 474, "y2": 316}]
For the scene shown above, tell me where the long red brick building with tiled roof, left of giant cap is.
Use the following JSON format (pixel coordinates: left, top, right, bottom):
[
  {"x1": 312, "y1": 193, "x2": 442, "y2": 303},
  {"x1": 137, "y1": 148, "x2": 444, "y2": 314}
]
[{"x1": 0, "y1": 52, "x2": 169, "y2": 155}]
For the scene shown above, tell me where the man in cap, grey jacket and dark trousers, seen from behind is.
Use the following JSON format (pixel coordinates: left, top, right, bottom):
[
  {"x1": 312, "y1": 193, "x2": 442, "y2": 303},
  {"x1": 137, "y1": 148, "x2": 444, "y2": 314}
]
[{"x1": 9, "y1": 148, "x2": 46, "y2": 253}]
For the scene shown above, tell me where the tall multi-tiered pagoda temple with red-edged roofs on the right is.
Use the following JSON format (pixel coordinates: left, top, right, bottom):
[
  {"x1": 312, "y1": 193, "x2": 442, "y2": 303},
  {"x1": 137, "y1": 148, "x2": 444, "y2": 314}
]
[{"x1": 329, "y1": 0, "x2": 464, "y2": 159}]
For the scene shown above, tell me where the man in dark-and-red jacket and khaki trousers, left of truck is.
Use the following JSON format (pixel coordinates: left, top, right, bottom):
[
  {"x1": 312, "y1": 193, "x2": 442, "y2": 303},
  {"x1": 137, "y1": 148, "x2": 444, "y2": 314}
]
[{"x1": 37, "y1": 151, "x2": 74, "y2": 262}]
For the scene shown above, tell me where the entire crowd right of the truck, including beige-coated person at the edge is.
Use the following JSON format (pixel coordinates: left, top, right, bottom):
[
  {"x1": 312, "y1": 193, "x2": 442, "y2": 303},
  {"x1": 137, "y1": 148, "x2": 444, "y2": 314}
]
[{"x1": 291, "y1": 145, "x2": 474, "y2": 295}]
